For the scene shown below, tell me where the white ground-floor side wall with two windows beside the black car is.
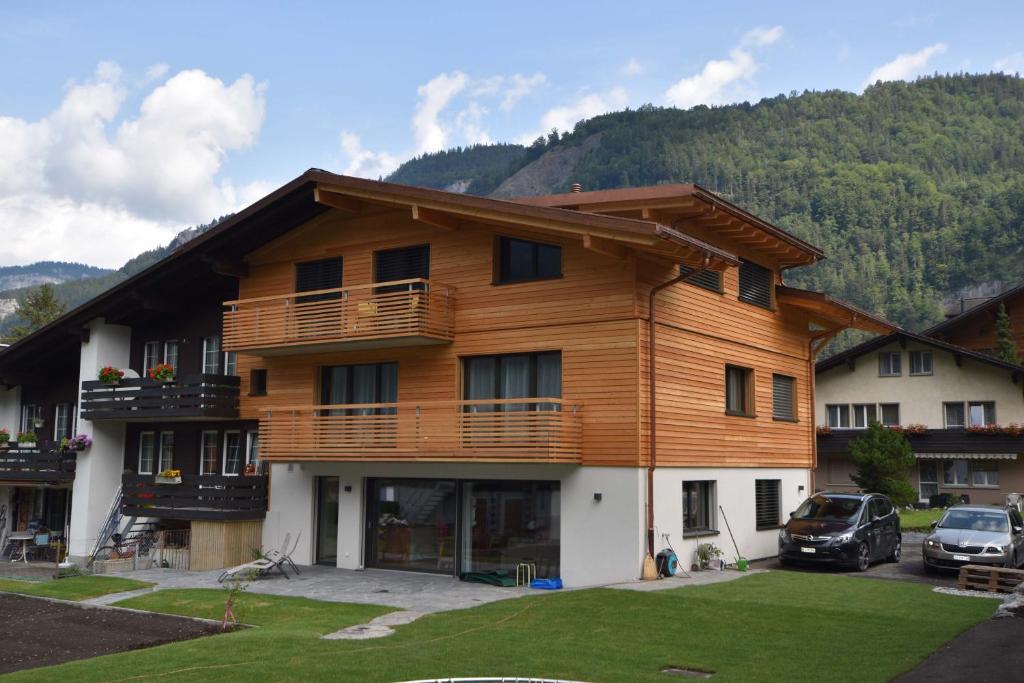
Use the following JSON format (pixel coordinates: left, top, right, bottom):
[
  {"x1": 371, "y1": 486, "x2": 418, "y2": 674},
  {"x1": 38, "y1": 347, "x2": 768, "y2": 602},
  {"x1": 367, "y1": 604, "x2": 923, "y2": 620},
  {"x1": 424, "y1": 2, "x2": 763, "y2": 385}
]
[{"x1": 654, "y1": 467, "x2": 810, "y2": 570}]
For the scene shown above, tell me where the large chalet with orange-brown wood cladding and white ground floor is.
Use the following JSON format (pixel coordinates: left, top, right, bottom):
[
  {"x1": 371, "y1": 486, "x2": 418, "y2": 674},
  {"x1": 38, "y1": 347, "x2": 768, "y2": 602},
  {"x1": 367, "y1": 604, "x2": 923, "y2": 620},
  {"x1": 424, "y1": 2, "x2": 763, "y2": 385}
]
[{"x1": 0, "y1": 170, "x2": 892, "y2": 586}]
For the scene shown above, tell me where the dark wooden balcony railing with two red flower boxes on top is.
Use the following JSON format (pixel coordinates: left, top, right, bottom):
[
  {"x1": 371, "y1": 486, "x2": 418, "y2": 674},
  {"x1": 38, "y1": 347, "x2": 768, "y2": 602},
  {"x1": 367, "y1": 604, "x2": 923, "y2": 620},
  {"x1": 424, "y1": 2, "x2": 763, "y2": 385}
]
[{"x1": 81, "y1": 375, "x2": 239, "y2": 422}]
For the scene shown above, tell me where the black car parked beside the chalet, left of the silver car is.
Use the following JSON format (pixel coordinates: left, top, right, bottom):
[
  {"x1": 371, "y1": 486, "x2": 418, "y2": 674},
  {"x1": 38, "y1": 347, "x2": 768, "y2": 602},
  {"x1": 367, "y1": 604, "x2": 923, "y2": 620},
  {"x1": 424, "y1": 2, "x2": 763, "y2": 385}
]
[{"x1": 778, "y1": 492, "x2": 903, "y2": 571}]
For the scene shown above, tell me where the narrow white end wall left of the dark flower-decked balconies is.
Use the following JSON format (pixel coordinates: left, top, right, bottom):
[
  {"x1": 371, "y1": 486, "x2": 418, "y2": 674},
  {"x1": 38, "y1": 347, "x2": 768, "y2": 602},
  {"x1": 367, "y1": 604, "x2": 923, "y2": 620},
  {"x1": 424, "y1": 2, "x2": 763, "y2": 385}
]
[{"x1": 69, "y1": 319, "x2": 131, "y2": 558}]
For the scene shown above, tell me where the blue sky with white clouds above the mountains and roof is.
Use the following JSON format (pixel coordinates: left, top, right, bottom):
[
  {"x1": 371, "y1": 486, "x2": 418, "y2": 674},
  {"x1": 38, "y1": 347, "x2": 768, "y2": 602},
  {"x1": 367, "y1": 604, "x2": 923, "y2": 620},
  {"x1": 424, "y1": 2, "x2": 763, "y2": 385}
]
[{"x1": 0, "y1": 0, "x2": 1024, "y2": 267}]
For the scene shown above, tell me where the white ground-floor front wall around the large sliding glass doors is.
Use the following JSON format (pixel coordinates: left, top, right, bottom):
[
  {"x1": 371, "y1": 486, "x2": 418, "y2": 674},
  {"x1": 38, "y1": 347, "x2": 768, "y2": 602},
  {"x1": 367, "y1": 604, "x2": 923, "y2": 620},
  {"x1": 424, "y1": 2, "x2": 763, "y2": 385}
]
[{"x1": 263, "y1": 463, "x2": 645, "y2": 586}]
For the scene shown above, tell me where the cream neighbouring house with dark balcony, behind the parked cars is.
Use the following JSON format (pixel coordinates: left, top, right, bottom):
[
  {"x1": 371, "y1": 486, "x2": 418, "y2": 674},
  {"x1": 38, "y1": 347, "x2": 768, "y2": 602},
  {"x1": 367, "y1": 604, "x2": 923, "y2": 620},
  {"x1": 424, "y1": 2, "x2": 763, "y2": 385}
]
[{"x1": 815, "y1": 331, "x2": 1024, "y2": 503}]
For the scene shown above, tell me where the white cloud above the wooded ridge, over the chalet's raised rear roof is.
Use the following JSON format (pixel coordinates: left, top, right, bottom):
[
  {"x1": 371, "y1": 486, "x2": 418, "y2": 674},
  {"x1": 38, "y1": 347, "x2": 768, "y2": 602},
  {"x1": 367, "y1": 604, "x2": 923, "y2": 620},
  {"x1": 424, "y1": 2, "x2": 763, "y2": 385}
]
[{"x1": 665, "y1": 26, "x2": 782, "y2": 109}]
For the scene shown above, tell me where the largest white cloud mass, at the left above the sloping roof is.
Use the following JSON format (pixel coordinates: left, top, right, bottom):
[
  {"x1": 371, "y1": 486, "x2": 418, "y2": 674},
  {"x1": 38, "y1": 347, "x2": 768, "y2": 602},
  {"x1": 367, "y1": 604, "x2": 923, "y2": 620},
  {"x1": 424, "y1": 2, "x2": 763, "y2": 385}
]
[{"x1": 0, "y1": 62, "x2": 266, "y2": 266}]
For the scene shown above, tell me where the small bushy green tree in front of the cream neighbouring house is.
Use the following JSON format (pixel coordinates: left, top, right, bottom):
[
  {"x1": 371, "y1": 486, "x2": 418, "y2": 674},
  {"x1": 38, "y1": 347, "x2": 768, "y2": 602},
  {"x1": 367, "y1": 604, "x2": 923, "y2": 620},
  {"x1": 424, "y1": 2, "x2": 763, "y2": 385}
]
[{"x1": 850, "y1": 422, "x2": 918, "y2": 505}]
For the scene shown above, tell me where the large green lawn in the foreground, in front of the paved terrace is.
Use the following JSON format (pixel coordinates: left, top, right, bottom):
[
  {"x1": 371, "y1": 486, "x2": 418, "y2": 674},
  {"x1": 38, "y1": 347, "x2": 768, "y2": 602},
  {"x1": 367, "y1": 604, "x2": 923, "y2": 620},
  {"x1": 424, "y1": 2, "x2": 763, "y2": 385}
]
[{"x1": 0, "y1": 571, "x2": 995, "y2": 683}]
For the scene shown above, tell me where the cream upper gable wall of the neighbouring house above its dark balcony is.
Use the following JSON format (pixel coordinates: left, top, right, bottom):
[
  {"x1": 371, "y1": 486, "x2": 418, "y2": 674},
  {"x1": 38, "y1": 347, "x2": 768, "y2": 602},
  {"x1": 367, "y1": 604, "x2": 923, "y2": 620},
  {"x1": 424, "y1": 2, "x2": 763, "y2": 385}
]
[{"x1": 815, "y1": 342, "x2": 1024, "y2": 429}]
